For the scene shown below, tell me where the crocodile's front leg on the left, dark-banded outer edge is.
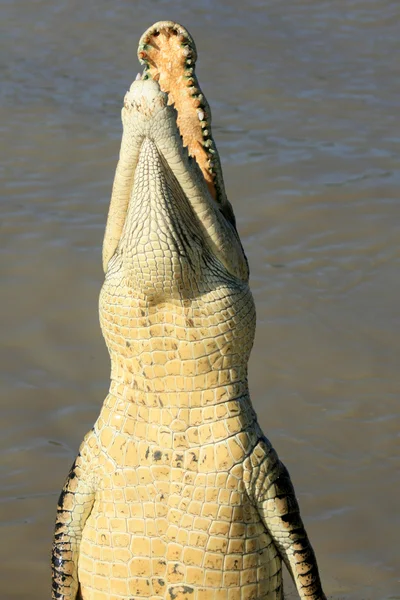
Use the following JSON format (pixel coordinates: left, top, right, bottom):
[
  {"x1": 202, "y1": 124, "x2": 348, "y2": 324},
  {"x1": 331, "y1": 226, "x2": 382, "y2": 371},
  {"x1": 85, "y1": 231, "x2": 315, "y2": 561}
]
[{"x1": 52, "y1": 444, "x2": 94, "y2": 600}]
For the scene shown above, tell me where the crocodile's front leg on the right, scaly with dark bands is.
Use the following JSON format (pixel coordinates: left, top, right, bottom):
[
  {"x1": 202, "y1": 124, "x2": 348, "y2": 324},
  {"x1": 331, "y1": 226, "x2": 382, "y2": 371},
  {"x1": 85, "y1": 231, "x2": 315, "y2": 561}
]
[{"x1": 248, "y1": 439, "x2": 326, "y2": 600}]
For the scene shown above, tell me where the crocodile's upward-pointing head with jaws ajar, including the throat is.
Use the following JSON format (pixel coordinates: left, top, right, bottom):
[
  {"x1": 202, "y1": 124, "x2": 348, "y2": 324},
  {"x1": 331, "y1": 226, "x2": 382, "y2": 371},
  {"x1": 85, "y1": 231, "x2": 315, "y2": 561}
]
[{"x1": 103, "y1": 21, "x2": 248, "y2": 296}]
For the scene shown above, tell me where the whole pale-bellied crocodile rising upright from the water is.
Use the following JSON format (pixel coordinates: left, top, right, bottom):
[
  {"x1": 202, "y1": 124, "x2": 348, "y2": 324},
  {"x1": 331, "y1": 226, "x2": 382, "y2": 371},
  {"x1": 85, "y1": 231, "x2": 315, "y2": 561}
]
[{"x1": 52, "y1": 21, "x2": 325, "y2": 600}]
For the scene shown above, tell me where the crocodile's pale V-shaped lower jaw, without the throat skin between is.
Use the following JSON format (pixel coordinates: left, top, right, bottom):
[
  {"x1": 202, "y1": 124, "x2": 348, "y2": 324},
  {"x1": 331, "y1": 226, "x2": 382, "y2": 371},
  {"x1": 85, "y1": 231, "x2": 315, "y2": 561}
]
[{"x1": 103, "y1": 79, "x2": 248, "y2": 281}]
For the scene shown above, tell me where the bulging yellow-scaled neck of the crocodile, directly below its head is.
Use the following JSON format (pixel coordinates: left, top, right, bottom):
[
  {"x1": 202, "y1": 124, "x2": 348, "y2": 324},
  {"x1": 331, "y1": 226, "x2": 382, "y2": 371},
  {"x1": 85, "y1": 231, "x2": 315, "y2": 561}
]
[{"x1": 100, "y1": 282, "x2": 254, "y2": 408}]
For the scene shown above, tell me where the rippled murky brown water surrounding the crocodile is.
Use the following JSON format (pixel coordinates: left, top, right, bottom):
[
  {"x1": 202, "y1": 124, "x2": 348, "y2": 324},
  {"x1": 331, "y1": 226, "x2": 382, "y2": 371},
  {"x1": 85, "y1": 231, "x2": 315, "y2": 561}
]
[{"x1": 0, "y1": 0, "x2": 400, "y2": 600}]
